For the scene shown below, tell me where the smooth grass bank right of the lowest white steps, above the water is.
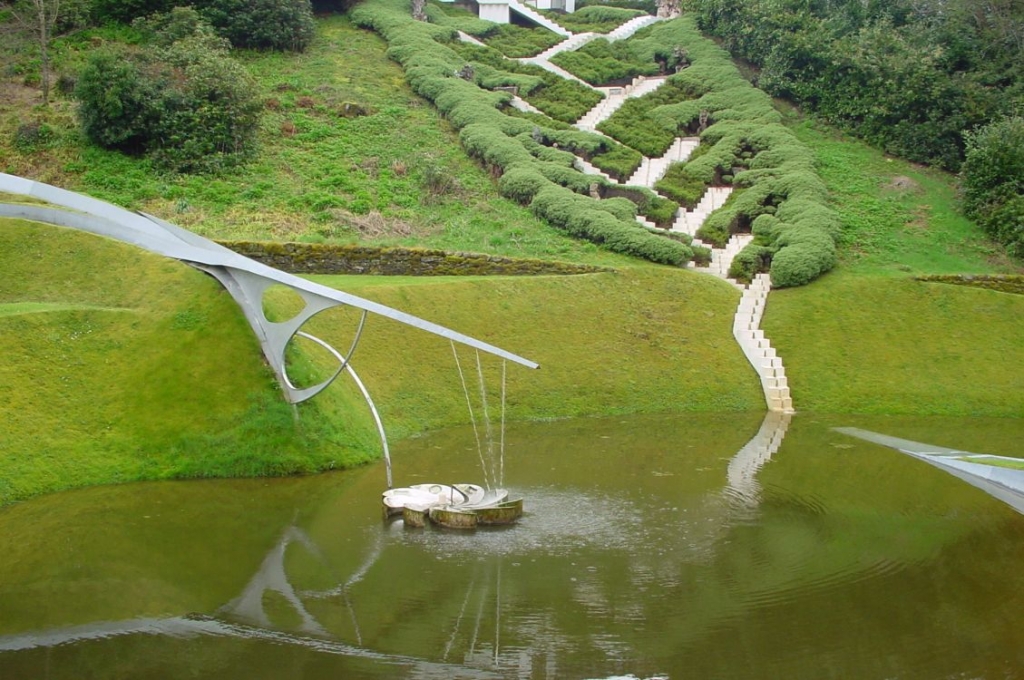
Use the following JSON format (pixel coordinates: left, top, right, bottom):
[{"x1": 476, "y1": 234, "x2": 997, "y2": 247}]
[{"x1": 762, "y1": 270, "x2": 1024, "y2": 418}]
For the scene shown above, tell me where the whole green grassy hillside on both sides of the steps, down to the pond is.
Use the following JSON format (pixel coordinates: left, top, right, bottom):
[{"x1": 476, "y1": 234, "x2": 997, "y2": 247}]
[{"x1": 0, "y1": 10, "x2": 1024, "y2": 505}]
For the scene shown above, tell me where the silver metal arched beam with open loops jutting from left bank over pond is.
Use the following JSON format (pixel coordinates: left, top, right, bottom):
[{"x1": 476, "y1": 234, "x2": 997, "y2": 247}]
[{"x1": 0, "y1": 173, "x2": 538, "y2": 403}]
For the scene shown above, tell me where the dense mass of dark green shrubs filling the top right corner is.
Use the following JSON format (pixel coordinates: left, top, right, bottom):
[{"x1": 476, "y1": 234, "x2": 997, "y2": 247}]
[{"x1": 692, "y1": 0, "x2": 1024, "y2": 170}]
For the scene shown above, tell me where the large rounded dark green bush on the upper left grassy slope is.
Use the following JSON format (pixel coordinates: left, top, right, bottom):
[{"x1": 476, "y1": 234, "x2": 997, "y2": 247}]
[{"x1": 76, "y1": 33, "x2": 261, "y2": 172}]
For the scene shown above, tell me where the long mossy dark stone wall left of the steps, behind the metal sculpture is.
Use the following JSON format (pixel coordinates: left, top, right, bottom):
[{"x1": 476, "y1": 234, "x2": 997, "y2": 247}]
[{"x1": 218, "y1": 241, "x2": 612, "y2": 277}]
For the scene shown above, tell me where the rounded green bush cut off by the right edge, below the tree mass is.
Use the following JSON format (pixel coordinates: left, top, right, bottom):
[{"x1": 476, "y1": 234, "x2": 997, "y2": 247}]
[{"x1": 961, "y1": 116, "x2": 1024, "y2": 258}]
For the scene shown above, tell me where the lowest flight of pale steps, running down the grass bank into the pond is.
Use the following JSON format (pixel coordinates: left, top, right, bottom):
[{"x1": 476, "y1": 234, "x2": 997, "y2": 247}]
[{"x1": 732, "y1": 273, "x2": 794, "y2": 413}]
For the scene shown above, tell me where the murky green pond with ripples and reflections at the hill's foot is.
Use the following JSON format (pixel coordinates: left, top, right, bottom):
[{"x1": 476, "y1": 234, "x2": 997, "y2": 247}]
[{"x1": 0, "y1": 414, "x2": 1024, "y2": 680}]
